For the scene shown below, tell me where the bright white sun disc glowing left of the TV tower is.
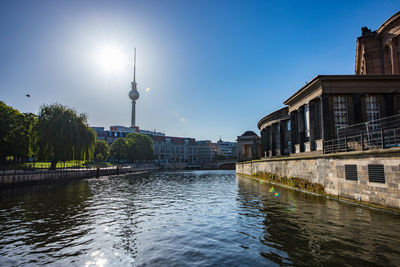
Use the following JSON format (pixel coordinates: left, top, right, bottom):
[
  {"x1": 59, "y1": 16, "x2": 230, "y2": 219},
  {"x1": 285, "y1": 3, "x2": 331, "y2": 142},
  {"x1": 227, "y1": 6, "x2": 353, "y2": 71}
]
[{"x1": 95, "y1": 45, "x2": 126, "y2": 73}]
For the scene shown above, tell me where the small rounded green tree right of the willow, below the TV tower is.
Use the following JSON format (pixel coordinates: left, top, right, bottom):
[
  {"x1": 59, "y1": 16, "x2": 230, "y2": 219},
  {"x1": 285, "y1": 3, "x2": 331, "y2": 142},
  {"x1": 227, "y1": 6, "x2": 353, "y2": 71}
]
[{"x1": 111, "y1": 133, "x2": 154, "y2": 161}]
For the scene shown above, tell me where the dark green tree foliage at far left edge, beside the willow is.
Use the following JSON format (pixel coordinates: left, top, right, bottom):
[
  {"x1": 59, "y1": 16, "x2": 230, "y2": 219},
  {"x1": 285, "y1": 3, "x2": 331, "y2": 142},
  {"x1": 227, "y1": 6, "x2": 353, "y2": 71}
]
[{"x1": 0, "y1": 101, "x2": 36, "y2": 161}]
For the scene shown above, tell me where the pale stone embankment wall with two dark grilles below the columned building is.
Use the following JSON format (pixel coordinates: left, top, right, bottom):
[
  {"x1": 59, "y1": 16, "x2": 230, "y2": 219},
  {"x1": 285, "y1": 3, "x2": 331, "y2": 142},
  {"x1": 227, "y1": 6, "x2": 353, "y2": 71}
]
[{"x1": 236, "y1": 149, "x2": 400, "y2": 210}]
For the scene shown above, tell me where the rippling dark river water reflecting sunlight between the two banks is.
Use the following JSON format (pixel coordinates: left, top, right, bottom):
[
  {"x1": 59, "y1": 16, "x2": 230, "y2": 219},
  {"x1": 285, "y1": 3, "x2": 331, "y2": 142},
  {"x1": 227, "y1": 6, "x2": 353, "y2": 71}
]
[{"x1": 0, "y1": 171, "x2": 400, "y2": 266}]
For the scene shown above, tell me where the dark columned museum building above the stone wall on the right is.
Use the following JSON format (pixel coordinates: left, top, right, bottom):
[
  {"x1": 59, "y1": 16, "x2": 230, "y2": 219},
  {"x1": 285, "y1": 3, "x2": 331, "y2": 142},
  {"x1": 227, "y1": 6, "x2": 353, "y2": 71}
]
[{"x1": 257, "y1": 12, "x2": 400, "y2": 157}]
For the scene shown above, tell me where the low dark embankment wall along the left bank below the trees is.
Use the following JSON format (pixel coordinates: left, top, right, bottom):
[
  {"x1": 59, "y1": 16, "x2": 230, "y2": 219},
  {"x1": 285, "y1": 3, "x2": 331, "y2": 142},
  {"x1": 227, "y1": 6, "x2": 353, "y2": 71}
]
[{"x1": 0, "y1": 165, "x2": 159, "y2": 187}]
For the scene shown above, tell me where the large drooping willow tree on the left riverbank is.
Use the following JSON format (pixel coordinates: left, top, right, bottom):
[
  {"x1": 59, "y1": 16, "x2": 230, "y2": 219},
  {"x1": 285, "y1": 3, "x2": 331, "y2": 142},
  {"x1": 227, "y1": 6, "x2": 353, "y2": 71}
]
[{"x1": 31, "y1": 103, "x2": 96, "y2": 170}]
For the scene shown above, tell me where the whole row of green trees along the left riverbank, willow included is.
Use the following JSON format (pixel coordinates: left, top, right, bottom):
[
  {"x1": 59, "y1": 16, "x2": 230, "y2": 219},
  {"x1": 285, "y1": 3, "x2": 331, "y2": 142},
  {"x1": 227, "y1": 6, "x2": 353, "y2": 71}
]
[{"x1": 0, "y1": 101, "x2": 153, "y2": 169}]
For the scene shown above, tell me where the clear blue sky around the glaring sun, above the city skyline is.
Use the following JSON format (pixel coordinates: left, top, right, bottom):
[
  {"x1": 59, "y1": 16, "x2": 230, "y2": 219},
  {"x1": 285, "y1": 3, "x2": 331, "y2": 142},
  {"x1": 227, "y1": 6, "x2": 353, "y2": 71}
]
[{"x1": 0, "y1": 0, "x2": 400, "y2": 141}]
